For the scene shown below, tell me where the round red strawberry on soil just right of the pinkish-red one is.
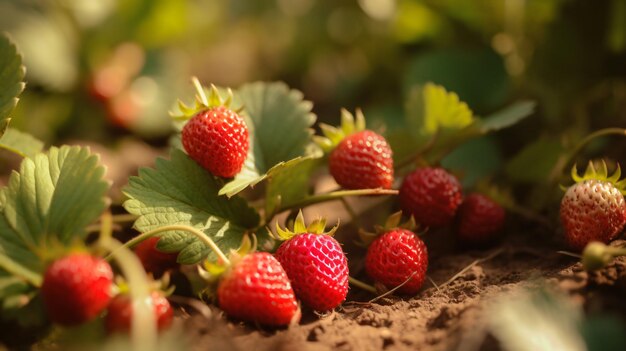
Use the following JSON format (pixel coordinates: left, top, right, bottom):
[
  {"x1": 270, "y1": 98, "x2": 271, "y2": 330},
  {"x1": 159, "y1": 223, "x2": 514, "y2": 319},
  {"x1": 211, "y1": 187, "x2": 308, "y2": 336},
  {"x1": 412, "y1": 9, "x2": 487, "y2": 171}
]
[{"x1": 365, "y1": 228, "x2": 428, "y2": 295}]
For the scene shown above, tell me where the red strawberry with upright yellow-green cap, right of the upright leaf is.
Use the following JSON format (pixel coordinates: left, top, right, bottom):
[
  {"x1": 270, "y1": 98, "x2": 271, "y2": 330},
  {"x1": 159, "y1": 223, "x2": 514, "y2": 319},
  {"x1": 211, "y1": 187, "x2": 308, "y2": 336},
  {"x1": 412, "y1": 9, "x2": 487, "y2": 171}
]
[{"x1": 316, "y1": 110, "x2": 393, "y2": 189}]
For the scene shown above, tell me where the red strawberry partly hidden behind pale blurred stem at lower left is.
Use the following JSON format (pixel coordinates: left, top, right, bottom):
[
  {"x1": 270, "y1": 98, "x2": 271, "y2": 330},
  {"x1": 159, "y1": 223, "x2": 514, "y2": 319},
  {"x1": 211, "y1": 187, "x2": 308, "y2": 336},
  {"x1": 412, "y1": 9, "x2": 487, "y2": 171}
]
[{"x1": 104, "y1": 291, "x2": 174, "y2": 334}]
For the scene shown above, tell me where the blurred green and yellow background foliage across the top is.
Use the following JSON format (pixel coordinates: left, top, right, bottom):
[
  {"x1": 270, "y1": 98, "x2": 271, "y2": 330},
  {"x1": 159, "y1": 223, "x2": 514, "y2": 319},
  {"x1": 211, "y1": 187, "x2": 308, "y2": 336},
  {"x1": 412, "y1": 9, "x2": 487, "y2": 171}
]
[{"x1": 0, "y1": 0, "x2": 626, "y2": 196}]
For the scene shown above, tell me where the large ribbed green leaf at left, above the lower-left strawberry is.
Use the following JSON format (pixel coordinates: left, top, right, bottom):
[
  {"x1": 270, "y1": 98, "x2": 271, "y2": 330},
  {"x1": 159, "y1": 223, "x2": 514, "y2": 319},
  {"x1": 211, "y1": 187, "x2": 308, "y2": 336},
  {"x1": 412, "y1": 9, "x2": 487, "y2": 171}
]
[{"x1": 0, "y1": 146, "x2": 109, "y2": 285}]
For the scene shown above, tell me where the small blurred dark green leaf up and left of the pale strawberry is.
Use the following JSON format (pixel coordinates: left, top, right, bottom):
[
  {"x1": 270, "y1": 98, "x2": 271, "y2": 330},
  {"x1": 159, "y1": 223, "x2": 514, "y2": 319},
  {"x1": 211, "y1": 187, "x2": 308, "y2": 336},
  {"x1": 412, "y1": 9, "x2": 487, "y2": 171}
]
[{"x1": 506, "y1": 138, "x2": 565, "y2": 183}]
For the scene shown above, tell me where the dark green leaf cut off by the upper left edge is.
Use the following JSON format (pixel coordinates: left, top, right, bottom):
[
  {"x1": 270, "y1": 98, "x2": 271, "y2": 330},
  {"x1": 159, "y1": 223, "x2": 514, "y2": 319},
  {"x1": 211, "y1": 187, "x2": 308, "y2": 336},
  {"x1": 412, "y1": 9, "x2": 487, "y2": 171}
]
[{"x1": 0, "y1": 34, "x2": 25, "y2": 136}]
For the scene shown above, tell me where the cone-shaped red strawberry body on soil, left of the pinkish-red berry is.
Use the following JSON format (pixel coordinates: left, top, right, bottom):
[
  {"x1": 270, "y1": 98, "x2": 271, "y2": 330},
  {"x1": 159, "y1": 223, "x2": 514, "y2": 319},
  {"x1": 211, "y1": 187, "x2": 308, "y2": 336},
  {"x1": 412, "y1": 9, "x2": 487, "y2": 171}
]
[{"x1": 217, "y1": 252, "x2": 299, "y2": 326}]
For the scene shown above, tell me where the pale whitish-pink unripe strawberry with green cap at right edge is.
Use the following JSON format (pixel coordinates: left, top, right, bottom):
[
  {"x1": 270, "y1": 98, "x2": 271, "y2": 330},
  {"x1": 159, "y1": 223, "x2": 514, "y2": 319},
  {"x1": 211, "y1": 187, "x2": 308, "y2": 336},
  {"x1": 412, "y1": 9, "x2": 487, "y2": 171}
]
[{"x1": 560, "y1": 162, "x2": 626, "y2": 251}]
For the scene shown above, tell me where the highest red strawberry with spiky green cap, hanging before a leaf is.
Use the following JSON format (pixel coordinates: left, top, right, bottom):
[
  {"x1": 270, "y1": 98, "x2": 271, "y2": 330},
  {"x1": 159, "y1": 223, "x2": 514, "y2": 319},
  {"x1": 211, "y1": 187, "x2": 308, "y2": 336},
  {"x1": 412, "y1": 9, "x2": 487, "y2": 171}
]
[{"x1": 181, "y1": 80, "x2": 249, "y2": 178}]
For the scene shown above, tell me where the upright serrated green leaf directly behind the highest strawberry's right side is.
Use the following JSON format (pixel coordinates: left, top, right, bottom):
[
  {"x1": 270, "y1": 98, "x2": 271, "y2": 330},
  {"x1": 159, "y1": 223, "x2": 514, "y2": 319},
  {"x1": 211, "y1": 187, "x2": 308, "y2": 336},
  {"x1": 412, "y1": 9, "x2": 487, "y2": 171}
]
[{"x1": 220, "y1": 82, "x2": 316, "y2": 196}]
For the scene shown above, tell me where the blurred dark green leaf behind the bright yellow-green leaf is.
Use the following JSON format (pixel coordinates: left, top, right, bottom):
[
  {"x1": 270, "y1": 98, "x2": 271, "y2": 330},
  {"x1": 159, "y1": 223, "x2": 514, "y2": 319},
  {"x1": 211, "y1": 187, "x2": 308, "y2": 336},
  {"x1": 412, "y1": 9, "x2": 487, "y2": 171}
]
[{"x1": 404, "y1": 49, "x2": 510, "y2": 111}]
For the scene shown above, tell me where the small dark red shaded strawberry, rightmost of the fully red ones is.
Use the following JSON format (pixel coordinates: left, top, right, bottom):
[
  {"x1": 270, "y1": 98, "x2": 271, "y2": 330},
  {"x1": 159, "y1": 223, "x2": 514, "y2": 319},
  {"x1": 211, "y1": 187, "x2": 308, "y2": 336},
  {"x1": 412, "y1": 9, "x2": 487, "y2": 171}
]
[{"x1": 457, "y1": 193, "x2": 505, "y2": 243}]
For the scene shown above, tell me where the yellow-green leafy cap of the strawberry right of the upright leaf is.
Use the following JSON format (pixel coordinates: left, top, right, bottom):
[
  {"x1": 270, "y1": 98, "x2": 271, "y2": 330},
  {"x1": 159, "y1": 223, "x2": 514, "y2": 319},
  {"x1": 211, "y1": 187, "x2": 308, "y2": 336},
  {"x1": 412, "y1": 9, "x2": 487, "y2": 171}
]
[{"x1": 313, "y1": 108, "x2": 365, "y2": 153}]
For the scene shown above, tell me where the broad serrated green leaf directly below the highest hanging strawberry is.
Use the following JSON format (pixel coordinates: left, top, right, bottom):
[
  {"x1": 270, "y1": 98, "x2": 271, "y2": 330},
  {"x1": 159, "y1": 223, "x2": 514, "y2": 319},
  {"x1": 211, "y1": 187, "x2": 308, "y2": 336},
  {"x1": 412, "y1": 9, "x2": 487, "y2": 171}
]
[{"x1": 124, "y1": 149, "x2": 259, "y2": 264}]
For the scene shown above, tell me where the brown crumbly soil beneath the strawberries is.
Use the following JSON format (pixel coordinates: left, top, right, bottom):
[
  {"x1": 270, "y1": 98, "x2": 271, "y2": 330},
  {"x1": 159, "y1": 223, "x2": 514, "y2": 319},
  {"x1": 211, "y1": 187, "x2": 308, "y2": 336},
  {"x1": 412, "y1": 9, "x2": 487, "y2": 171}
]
[{"x1": 173, "y1": 219, "x2": 626, "y2": 351}]
